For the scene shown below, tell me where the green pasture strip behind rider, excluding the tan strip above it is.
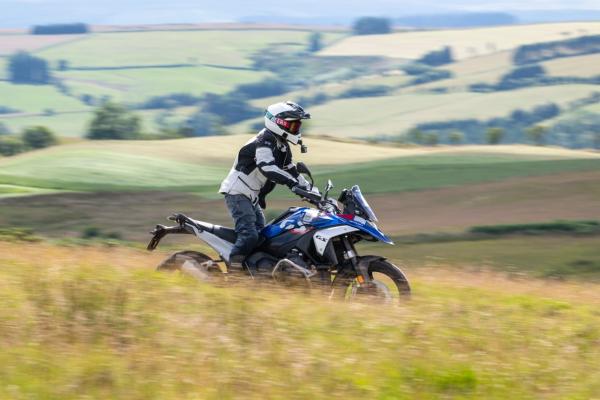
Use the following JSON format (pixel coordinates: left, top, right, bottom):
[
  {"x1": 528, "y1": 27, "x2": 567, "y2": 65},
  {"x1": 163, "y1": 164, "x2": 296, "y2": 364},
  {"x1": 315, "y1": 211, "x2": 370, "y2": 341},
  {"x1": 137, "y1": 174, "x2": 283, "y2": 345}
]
[{"x1": 0, "y1": 141, "x2": 600, "y2": 197}]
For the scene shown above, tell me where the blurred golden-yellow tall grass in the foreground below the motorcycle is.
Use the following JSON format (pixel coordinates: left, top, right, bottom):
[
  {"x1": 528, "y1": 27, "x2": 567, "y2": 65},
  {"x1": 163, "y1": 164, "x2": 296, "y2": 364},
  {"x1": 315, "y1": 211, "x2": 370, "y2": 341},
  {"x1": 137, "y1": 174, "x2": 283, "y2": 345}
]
[{"x1": 0, "y1": 239, "x2": 600, "y2": 399}]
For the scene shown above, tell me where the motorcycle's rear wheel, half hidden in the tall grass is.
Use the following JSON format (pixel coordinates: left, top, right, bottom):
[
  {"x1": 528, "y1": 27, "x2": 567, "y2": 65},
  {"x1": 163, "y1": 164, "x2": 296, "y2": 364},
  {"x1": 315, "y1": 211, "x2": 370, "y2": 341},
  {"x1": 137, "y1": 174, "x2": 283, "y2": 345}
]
[{"x1": 156, "y1": 250, "x2": 223, "y2": 281}]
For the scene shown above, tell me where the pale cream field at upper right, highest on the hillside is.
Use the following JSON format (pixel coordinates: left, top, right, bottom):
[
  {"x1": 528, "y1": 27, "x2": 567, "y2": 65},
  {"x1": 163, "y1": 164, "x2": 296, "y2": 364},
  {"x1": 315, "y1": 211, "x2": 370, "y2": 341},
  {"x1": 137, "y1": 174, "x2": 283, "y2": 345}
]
[{"x1": 320, "y1": 22, "x2": 600, "y2": 60}]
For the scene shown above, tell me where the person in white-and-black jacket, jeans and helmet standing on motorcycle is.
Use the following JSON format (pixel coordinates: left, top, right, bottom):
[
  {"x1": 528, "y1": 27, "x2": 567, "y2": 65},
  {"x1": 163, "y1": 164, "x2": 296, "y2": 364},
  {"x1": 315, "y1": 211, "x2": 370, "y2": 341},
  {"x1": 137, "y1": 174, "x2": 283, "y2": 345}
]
[{"x1": 219, "y1": 101, "x2": 310, "y2": 269}]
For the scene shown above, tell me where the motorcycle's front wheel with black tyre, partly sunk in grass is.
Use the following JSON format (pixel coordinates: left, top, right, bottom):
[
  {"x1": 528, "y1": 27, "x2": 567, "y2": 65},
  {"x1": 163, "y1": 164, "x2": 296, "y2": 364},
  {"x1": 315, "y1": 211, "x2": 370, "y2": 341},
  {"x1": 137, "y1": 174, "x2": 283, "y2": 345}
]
[{"x1": 337, "y1": 258, "x2": 410, "y2": 304}]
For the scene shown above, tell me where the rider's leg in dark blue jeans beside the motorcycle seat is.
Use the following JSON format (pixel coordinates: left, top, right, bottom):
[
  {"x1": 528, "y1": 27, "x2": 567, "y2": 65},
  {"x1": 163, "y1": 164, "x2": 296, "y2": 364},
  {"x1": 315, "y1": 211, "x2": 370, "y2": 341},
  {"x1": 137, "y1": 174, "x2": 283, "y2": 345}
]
[{"x1": 225, "y1": 194, "x2": 258, "y2": 268}]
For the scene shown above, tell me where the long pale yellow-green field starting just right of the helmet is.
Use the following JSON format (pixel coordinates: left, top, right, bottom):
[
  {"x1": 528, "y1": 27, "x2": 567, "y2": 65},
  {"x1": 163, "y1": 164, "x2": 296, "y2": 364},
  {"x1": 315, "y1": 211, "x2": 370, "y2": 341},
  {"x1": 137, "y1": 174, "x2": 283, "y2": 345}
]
[{"x1": 292, "y1": 85, "x2": 598, "y2": 138}]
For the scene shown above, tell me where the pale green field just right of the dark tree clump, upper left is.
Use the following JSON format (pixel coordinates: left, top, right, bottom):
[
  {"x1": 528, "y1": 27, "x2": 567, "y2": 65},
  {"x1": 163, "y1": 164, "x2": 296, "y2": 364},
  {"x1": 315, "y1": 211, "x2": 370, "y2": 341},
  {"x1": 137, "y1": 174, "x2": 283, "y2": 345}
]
[{"x1": 59, "y1": 67, "x2": 268, "y2": 103}]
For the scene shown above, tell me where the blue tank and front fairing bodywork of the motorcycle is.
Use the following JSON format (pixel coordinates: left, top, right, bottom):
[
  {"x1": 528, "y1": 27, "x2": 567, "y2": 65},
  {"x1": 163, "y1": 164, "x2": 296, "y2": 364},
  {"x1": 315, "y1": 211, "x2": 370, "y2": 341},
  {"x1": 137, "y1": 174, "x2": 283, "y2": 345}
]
[{"x1": 261, "y1": 207, "x2": 394, "y2": 244}]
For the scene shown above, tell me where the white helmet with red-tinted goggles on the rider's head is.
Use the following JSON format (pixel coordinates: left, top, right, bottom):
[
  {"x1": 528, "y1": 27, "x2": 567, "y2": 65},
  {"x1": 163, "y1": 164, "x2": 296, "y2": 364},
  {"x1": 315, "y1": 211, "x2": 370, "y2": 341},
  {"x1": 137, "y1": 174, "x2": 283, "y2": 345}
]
[{"x1": 265, "y1": 101, "x2": 310, "y2": 144}]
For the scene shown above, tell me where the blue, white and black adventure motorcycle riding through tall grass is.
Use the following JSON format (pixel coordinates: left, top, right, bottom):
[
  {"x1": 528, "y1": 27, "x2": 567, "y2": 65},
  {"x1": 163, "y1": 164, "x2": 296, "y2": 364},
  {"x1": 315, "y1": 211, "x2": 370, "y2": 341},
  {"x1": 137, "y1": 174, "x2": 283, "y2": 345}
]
[{"x1": 147, "y1": 163, "x2": 410, "y2": 303}]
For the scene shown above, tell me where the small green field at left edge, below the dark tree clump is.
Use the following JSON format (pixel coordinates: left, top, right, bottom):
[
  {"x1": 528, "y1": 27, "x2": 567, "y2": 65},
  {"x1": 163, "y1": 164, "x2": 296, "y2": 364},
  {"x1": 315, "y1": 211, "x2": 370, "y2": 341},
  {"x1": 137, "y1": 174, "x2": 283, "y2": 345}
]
[{"x1": 0, "y1": 82, "x2": 89, "y2": 113}]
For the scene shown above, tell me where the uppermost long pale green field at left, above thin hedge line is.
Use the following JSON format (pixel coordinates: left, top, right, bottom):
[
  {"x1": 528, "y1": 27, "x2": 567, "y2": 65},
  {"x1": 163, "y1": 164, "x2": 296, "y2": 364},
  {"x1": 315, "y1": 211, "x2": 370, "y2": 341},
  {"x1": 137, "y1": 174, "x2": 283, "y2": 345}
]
[{"x1": 36, "y1": 30, "x2": 340, "y2": 67}]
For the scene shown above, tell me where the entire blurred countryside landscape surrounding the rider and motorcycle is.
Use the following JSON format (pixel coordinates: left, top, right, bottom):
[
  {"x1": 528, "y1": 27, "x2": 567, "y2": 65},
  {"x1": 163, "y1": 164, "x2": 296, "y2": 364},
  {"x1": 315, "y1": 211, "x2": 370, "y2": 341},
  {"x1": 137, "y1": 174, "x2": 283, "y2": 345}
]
[{"x1": 0, "y1": 0, "x2": 600, "y2": 399}]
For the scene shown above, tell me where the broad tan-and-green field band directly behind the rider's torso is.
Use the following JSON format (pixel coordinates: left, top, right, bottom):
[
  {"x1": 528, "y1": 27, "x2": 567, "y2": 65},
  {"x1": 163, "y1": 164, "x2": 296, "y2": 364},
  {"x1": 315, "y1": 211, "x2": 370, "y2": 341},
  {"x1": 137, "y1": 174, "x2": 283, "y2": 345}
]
[{"x1": 0, "y1": 136, "x2": 600, "y2": 197}]
